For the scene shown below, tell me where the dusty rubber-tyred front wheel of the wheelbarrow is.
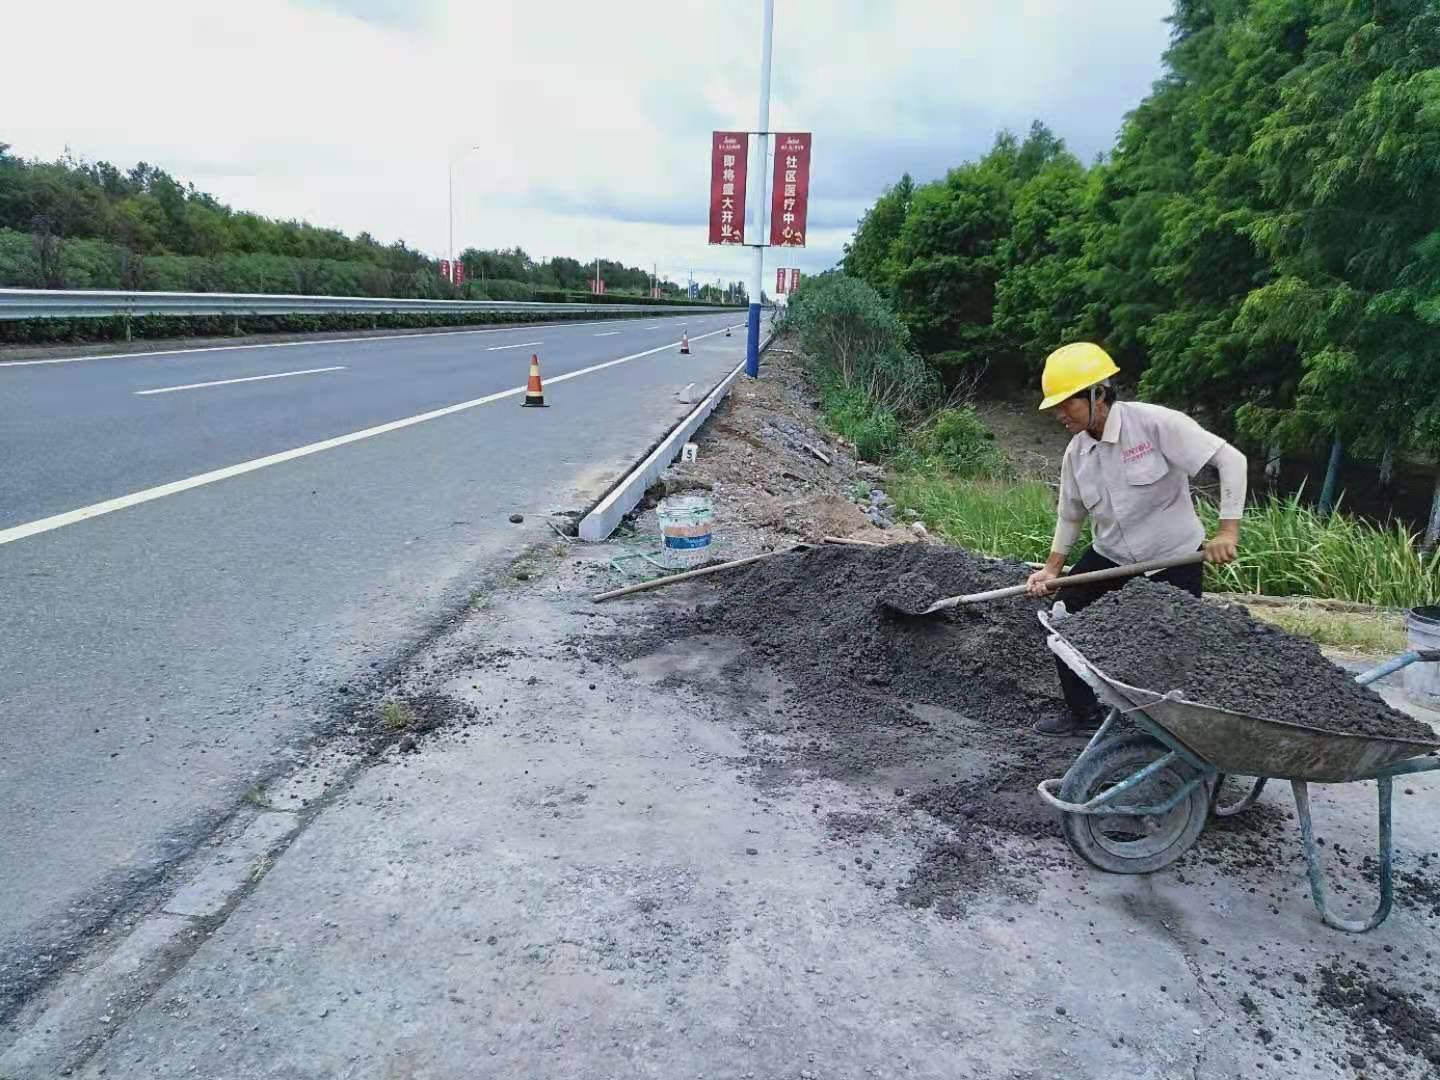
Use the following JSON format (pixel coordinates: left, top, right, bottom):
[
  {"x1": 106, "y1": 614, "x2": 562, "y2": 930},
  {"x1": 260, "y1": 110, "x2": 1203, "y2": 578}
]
[{"x1": 1060, "y1": 732, "x2": 1210, "y2": 874}]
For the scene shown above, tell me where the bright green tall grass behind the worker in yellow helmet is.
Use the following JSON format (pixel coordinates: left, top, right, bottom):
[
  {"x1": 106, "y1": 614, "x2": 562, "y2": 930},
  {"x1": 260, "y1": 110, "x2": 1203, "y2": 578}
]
[{"x1": 891, "y1": 469, "x2": 1440, "y2": 608}]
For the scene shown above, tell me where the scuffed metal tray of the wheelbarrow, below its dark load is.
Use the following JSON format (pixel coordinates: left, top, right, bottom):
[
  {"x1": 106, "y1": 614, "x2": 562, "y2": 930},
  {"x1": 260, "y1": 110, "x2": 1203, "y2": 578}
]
[{"x1": 1041, "y1": 630, "x2": 1440, "y2": 783}]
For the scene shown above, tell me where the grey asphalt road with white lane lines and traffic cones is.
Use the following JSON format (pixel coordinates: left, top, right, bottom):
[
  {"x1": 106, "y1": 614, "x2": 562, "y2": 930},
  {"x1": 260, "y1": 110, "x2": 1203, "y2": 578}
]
[{"x1": 0, "y1": 308, "x2": 744, "y2": 1015}]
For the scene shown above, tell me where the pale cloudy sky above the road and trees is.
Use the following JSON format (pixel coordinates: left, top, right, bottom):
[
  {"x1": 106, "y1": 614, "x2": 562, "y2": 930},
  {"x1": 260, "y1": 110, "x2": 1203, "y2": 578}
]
[{"x1": 0, "y1": 0, "x2": 1171, "y2": 289}]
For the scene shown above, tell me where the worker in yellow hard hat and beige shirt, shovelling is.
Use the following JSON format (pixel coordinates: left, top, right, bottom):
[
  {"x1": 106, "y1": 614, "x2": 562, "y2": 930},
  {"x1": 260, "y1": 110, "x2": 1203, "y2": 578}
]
[{"x1": 1027, "y1": 341, "x2": 1246, "y2": 736}]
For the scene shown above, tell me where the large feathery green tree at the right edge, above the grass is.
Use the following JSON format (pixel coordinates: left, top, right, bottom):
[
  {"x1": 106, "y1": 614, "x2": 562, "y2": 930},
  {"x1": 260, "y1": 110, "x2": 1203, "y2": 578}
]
[{"x1": 1244, "y1": 0, "x2": 1440, "y2": 472}]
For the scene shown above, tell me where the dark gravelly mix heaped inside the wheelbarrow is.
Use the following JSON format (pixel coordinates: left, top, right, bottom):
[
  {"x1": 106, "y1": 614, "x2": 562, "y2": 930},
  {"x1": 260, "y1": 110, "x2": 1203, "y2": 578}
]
[{"x1": 1057, "y1": 577, "x2": 1436, "y2": 742}]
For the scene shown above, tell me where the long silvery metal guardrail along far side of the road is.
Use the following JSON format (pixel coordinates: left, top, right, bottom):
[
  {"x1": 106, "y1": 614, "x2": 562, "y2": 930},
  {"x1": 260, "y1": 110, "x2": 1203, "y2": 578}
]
[{"x1": 0, "y1": 289, "x2": 734, "y2": 320}]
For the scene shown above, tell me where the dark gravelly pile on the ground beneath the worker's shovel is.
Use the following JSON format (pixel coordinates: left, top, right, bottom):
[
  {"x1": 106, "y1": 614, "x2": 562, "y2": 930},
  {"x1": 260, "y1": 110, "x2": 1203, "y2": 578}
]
[{"x1": 606, "y1": 544, "x2": 1077, "y2": 916}]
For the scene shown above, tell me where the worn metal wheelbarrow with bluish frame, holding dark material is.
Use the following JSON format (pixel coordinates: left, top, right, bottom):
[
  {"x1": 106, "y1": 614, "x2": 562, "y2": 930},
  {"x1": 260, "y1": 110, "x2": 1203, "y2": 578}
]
[{"x1": 1040, "y1": 612, "x2": 1440, "y2": 933}]
